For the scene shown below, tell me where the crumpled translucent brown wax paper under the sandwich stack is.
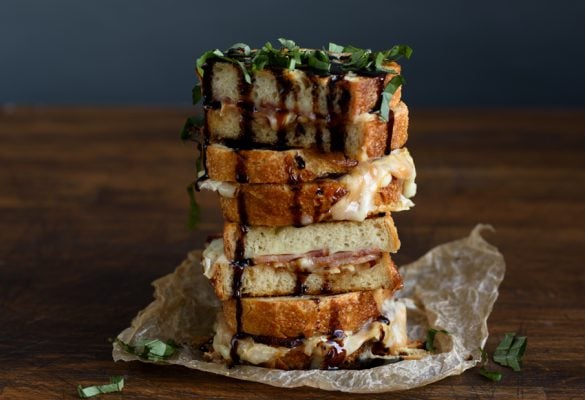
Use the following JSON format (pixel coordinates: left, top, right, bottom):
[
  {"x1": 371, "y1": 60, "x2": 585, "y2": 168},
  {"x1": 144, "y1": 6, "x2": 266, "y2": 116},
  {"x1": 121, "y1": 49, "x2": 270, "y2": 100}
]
[{"x1": 113, "y1": 225, "x2": 505, "y2": 393}]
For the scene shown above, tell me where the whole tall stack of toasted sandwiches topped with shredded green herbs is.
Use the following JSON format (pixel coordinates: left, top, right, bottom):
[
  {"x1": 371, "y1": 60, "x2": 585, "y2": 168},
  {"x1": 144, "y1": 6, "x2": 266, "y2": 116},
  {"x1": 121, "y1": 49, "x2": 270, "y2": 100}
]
[{"x1": 184, "y1": 39, "x2": 423, "y2": 369}]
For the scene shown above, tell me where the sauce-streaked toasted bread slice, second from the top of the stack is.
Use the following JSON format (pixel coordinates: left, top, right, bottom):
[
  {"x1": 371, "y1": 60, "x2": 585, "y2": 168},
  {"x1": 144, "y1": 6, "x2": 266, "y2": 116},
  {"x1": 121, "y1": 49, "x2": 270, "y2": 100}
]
[{"x1": 205, "y1": 102, "x2": 408, "y2": 161}]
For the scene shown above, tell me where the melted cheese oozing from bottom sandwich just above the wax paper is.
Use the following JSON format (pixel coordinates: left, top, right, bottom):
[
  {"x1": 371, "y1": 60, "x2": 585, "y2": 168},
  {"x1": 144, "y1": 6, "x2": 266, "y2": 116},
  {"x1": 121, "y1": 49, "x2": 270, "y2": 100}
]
[{"x1": 213, "y1": 299, "x2": 408, "y2": 365}]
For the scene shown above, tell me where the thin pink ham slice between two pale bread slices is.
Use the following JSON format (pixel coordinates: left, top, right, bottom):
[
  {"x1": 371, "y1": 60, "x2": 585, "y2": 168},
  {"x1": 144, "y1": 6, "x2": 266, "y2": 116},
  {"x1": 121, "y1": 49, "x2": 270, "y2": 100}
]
[{"x1": 254, "y1": 249, "x2": 382, "y2": 268}]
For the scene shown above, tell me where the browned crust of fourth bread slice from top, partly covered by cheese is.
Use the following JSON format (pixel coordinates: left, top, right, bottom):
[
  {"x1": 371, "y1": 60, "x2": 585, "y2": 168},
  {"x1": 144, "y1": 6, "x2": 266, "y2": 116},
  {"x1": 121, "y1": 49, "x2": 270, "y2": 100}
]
[{"x1": 219, "y1": 179, "x2": 405, "y2": 226}]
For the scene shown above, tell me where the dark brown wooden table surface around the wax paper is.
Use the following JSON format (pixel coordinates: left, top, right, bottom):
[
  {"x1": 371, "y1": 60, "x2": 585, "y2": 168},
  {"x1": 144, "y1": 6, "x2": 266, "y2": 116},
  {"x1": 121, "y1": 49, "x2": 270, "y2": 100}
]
[{"x1": 0, "y1": 108, "x2": 585, "y2": 399}]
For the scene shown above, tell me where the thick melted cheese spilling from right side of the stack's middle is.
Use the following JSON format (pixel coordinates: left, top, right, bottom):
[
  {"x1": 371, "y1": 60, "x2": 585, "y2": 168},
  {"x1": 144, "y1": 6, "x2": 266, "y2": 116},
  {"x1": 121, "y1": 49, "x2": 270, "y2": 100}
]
[{"x1": 331, "y1": 148, "x2": 416, "y2": 221}]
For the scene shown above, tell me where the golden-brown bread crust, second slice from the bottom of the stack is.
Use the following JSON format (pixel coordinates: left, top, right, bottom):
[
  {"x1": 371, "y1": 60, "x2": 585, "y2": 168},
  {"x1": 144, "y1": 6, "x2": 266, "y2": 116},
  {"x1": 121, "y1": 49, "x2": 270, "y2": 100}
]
[{"x1": 222, "y1": 289, "x2": 392, "y2": 339}]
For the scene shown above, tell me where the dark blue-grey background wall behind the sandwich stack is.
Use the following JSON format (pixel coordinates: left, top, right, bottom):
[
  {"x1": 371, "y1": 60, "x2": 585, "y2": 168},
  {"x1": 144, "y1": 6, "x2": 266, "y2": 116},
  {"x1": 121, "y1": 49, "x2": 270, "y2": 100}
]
[{"x1": 0, "y1": 0, "x2": 585, "y2": 107}]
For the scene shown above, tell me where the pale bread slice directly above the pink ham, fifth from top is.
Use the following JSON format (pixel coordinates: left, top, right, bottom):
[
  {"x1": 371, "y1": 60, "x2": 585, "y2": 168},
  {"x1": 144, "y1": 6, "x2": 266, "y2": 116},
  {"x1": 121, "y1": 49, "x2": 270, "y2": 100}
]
[{"x1": 223, "y1": 215, "x2": 400, "y2": 260}]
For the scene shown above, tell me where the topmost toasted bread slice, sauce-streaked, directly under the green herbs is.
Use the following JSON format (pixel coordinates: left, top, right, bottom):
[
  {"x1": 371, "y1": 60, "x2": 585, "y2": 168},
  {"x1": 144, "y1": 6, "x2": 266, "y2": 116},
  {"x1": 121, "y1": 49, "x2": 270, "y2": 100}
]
[{"x1": 202, "y1": 60, "x2": 401, "y2": 117}]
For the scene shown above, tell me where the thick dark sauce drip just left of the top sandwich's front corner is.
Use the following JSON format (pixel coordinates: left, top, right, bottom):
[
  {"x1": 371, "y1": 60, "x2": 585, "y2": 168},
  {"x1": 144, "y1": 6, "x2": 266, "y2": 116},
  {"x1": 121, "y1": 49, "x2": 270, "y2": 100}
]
[{"x1": 327, "y1": 75, "x2": 351, "y2": 152}]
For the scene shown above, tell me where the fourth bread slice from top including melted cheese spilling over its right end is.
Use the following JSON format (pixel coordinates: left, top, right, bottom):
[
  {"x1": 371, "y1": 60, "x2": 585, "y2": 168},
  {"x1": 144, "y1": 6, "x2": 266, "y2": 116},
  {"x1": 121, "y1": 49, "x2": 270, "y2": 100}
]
[{"x1": 200, "y1": 148, "x2": 416, "y2": 226}]
